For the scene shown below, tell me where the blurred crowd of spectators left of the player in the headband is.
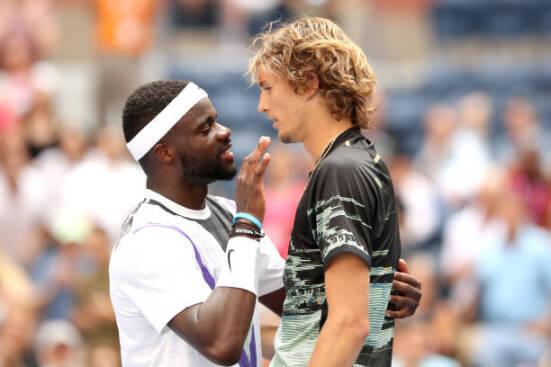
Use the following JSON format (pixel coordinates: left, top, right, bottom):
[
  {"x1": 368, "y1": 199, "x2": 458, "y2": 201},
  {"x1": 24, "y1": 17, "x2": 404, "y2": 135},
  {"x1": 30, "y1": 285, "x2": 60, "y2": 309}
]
[{"x1": 0, "y1": 0, "x2": 145, "y2": 367}]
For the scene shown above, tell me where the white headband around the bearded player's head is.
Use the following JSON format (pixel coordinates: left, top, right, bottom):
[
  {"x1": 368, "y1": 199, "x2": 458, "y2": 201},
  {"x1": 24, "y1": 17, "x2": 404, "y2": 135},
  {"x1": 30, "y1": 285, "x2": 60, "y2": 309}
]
[{"x1": 126, "y1": 82, "x2": 208, "y2": 161}]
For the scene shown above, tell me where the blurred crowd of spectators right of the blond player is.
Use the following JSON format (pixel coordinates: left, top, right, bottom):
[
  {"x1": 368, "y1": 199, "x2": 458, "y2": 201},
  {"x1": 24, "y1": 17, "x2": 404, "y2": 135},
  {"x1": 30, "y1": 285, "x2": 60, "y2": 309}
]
[{"x1": 384, "y1": 93, "x2": 551, "y2": 367}]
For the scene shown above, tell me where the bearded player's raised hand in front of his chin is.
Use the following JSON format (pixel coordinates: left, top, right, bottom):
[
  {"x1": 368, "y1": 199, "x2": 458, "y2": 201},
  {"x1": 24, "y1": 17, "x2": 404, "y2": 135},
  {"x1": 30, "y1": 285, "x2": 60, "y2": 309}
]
[{"x1": 235, "y1": 136, "x2": 270, "y2": 222}]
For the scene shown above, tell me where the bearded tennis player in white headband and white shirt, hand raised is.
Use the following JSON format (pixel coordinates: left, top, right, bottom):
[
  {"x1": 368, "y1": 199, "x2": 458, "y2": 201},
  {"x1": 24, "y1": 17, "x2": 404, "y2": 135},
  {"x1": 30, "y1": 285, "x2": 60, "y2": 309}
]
[{"x1": 109, "y1": 81, "x2": 422, "y2": 367}]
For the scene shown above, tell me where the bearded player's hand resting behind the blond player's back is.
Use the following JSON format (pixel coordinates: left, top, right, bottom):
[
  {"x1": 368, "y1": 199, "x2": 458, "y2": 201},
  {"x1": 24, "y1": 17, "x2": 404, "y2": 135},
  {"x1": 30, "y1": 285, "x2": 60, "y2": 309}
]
[{"x1": 386, "y1": 259, "x2": 421, "y2": 319}]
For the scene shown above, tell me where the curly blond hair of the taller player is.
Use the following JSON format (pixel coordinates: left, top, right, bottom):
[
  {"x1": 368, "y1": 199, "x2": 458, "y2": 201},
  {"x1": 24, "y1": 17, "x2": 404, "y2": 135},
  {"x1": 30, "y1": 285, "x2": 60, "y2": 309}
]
[{"x1": 247, "y1": 17, "x2": 376, "y2": 129}]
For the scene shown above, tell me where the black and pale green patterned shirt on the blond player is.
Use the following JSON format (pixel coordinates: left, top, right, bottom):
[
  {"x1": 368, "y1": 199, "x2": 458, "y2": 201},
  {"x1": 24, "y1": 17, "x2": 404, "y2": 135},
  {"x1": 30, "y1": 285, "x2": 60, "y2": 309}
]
[{"x1": 270, "y1": 128, "x2": 401, "y2": 367}]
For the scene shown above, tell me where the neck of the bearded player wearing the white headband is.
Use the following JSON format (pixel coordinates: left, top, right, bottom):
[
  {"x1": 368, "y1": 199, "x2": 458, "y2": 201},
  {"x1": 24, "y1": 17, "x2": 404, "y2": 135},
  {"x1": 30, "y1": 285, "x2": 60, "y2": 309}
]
[{"x1": 146, "y1": 177, "x2": 208, "y2": 210}]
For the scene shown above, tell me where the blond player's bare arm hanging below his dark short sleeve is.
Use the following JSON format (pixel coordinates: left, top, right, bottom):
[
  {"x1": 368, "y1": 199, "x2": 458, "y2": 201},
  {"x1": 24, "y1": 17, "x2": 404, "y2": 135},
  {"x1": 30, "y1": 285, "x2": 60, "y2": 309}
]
[{"x1": 309, "y1": 254, "x2": 369, "y2": 367}]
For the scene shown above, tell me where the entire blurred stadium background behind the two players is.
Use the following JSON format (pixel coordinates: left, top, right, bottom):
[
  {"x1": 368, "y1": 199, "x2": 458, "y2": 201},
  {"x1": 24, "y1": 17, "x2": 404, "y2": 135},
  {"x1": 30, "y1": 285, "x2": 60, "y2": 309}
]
[{"x1": 0, "y1": 0, "x2": 551, "y2": 367}]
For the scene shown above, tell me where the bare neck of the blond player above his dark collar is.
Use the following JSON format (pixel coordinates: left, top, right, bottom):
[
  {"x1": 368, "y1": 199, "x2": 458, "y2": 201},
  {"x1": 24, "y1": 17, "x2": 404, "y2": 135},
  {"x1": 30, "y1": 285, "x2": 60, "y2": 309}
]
[{"x1": 303, "y1": 117, "x2": 354, "y2": 162}]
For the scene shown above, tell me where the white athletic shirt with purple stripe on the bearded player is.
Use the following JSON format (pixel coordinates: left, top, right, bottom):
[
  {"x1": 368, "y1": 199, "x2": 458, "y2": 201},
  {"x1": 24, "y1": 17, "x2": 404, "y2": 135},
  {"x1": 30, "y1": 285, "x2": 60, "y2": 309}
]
[{"x1": 109, "y1": 190, "x2": 284, "y2": 367}]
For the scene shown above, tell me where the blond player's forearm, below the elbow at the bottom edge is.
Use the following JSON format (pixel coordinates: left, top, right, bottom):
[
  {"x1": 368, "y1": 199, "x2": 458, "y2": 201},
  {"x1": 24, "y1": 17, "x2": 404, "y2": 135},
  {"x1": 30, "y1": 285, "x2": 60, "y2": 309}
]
[{"x1": 308, "y1": 319, "x2": 369, "y2": 367}]
